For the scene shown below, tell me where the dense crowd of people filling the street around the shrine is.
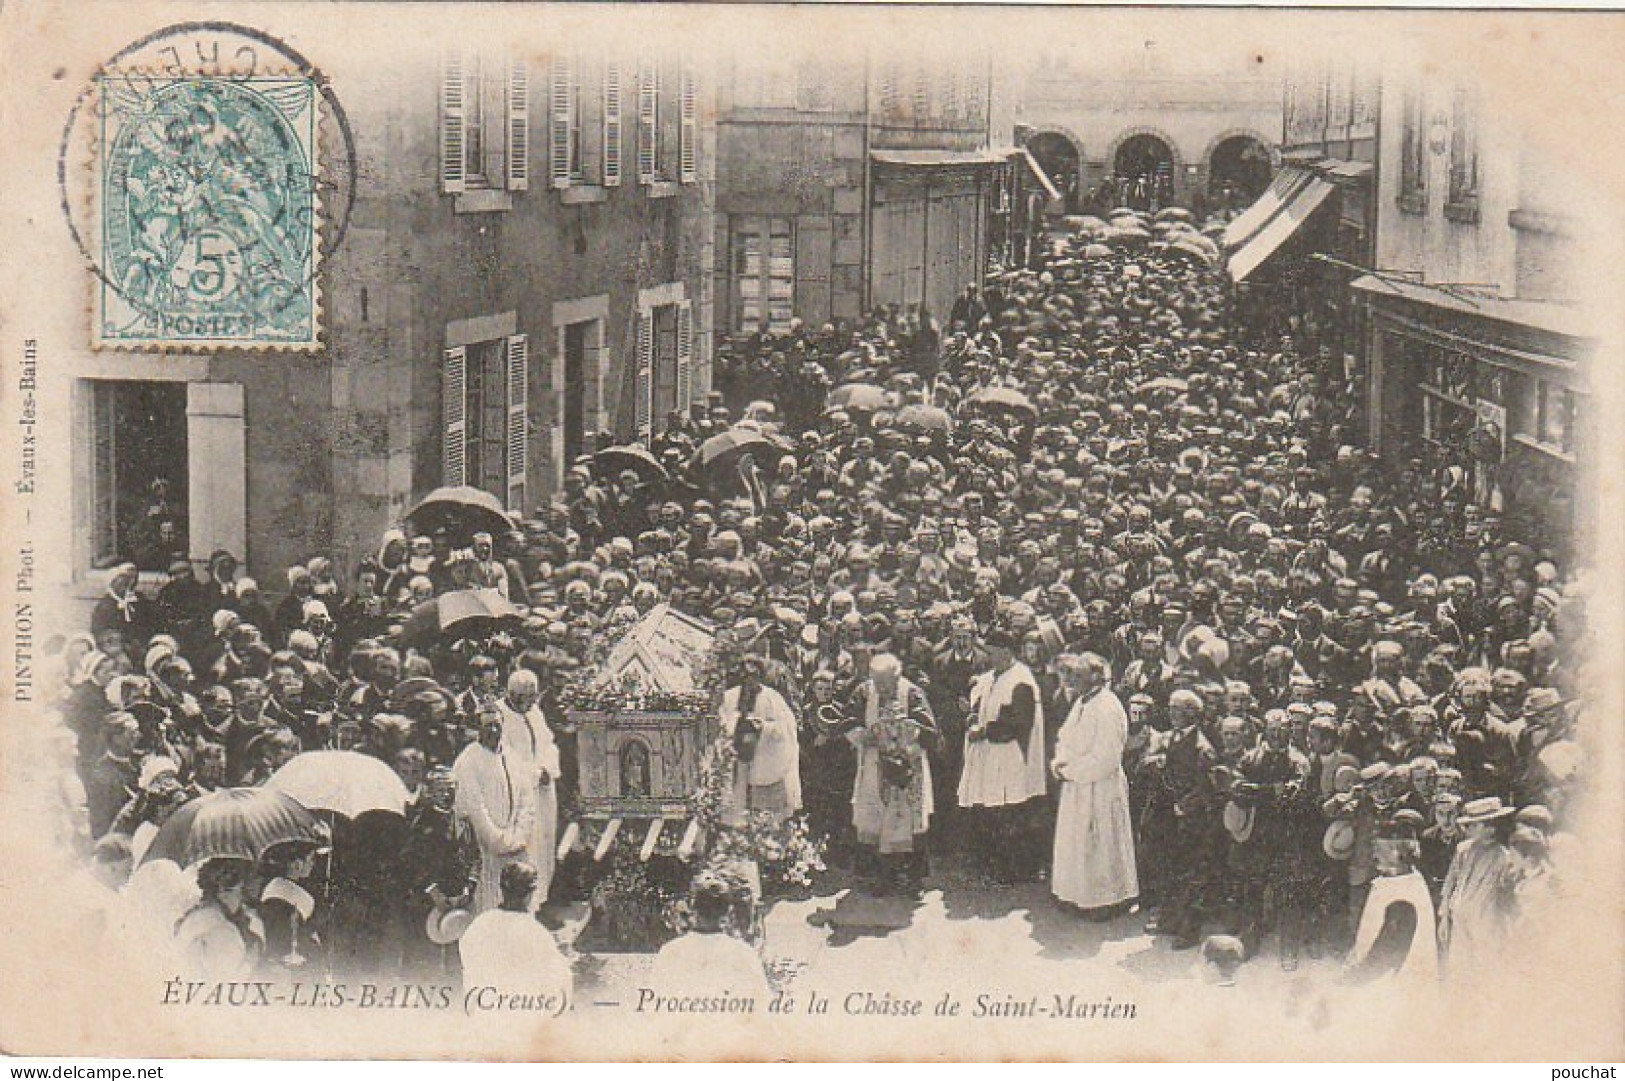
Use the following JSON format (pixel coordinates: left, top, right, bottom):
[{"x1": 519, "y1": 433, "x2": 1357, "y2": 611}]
[{"x1": 34, "y1": 206, "x2": 1584, "y2": 972}]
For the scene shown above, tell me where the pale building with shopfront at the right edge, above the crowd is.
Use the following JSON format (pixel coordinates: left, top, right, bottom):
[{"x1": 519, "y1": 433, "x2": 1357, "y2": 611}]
[{"x1": 1354, "y1": 60, "x2": 1599, "y2": 546}]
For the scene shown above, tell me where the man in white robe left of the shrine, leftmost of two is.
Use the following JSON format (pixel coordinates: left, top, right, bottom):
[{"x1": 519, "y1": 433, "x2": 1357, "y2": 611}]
[{"x1": 452, "y1": 702, "x2": 536, "y2": 914}]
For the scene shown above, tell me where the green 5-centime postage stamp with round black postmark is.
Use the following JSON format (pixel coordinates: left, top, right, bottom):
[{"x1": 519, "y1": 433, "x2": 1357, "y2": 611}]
[{"x1": 96, "y1": 72, "x2": 322, "y2": 349}]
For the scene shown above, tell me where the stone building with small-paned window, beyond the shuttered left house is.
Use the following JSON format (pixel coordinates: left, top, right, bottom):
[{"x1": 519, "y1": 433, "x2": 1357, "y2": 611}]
[{"x1": 715, "y1": 50, "x2": 1040, "y2": 333}]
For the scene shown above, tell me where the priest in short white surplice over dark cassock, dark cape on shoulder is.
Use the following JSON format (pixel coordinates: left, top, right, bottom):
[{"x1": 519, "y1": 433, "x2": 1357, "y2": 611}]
[{"x1": 959, "y1": 624, "x2": 1047, "y2": 883}]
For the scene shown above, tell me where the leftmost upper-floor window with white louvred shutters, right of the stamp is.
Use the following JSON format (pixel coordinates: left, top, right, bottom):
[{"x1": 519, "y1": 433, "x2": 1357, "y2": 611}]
[{"x1": 440, "y1": 55, "x2": 530, "y2": 195}]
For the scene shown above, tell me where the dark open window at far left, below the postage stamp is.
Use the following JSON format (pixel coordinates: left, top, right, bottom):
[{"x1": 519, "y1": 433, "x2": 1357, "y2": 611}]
[{"x1": 85, "y1": 380, "x2": 187, "y2": 571}]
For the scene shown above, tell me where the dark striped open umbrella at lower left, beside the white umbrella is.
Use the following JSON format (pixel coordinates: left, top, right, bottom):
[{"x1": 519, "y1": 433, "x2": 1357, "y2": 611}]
[{"x1": 141, "y1": 788, "x2": 327, "y2": 868}]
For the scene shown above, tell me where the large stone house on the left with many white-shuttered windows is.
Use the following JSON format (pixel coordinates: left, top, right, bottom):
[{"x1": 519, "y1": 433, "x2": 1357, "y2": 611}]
[{"x1": 70, "y1": 29, "x2": 717, "y2": 598}]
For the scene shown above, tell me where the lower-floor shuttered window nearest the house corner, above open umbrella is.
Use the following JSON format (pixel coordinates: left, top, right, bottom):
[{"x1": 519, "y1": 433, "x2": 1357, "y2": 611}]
[{"x1": 440, "y1": 335, "x2": 530, "y2": 509}]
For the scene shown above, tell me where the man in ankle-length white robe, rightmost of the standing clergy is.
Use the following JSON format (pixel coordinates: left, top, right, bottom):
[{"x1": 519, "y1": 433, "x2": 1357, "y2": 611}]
[{"x1": 1050, "y1": 653, "x2": 1139, "y2": 915}]
